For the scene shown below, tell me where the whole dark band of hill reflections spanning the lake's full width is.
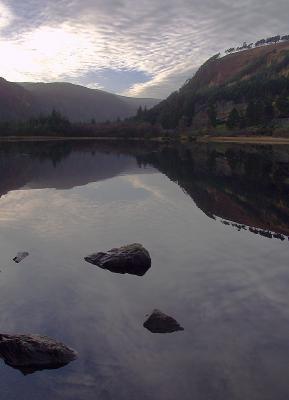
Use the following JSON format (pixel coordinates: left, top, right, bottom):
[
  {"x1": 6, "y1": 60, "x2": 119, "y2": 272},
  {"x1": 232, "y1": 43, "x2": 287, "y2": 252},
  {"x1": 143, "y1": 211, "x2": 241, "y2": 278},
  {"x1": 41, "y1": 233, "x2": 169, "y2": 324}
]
[{"x1": 0, "y1": 142, "x2": 289, "y2": 240}]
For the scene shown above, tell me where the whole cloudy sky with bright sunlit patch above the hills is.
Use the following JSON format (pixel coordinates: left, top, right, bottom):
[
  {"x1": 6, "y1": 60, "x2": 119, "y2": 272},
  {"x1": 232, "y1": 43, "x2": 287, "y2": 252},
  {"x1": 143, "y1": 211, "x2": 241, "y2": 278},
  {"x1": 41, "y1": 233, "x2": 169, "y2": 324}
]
[{"x1": 0, "y1": 0, "x2": 289, "y2": 99}]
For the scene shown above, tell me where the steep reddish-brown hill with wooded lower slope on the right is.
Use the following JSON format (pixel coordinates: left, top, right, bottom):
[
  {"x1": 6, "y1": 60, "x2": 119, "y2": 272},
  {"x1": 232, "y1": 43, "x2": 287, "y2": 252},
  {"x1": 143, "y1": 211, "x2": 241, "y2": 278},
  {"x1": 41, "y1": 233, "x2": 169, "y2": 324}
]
[{"x1": 142, "y1": 41, "x2": 289, "y2": 130}]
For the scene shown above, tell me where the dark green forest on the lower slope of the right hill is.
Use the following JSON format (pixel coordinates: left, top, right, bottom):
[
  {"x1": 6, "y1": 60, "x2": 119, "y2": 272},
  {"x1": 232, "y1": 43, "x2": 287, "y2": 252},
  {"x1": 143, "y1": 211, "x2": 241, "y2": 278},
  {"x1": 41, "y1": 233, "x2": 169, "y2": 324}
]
[{"x1": 139, "y1": 73, "x2": 289, "y2": 129}]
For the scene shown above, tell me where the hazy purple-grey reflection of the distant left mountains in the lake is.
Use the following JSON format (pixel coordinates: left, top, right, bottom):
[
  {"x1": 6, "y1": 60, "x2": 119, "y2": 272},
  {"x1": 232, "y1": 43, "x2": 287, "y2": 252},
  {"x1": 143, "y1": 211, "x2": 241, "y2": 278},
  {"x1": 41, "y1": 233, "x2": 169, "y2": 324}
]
[{"x1": 0, "y1": 142, "x2": 153, "y2": 196}]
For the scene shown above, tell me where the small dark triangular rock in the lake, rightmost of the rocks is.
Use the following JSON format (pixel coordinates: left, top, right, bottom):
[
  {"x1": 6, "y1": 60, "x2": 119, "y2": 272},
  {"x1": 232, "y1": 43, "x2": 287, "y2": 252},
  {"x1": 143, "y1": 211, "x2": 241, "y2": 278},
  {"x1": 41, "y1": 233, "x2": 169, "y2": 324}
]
[{"x1": 143, "y1": 310, "x2": 184, "y2": 333}]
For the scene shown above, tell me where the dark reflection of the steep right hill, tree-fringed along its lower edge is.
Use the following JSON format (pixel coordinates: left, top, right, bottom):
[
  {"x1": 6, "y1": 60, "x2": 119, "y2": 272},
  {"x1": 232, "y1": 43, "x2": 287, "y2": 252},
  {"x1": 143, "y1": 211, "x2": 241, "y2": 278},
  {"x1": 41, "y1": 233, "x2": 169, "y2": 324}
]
[{"x1": 136, "y1": 144, "x2": 289, "y2": 240}]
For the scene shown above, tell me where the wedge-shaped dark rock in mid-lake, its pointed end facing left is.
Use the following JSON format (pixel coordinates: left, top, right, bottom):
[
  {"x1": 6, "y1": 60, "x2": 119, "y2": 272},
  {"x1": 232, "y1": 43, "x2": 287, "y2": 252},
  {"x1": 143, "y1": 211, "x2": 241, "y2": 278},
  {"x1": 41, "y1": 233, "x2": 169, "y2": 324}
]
[{"x1": 85, "y1": 243, "x2": 151, "y2": 276}]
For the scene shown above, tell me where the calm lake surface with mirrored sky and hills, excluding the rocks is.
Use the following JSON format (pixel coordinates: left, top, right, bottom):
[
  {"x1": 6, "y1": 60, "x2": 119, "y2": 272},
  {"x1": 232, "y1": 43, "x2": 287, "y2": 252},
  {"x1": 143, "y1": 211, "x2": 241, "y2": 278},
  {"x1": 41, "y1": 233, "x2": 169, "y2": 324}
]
[{"x1": 0, "y1": 142, "x2": 289, "y2": 400}]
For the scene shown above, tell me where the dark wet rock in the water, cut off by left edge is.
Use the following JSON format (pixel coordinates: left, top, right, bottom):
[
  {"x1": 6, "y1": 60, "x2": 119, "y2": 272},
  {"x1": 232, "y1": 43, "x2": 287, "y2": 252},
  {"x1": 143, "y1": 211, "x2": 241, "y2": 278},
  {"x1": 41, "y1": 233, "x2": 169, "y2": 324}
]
[{"x1": 0, "y1": 334, "x2": 77, "y2": 375}]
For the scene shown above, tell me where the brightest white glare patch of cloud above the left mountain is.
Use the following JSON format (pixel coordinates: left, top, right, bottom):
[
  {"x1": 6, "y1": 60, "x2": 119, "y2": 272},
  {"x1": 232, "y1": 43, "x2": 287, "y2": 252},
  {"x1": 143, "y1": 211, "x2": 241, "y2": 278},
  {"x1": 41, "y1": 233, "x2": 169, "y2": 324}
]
[{"x1": 0, "y1": 25, "x2": 95, "y2": 81}]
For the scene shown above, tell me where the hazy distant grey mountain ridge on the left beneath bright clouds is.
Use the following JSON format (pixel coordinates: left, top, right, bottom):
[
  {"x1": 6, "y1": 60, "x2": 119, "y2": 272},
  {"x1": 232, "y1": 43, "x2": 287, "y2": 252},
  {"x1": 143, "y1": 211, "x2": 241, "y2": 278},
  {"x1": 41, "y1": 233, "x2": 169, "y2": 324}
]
[{"x1": 0, "y1": 78, "x2": 159, "y2": 122}]
